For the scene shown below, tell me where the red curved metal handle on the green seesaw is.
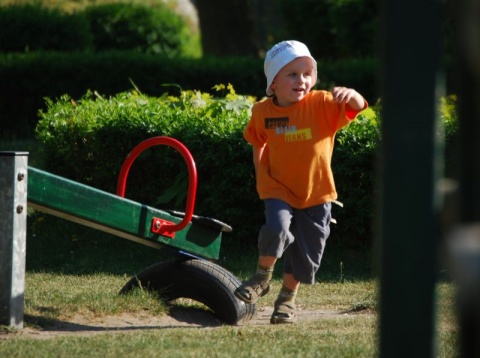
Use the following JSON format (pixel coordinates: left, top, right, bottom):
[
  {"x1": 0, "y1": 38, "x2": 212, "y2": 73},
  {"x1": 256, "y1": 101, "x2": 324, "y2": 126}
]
[{"x1": 117, "y1": 136, "x2": 197, "y2": 232}]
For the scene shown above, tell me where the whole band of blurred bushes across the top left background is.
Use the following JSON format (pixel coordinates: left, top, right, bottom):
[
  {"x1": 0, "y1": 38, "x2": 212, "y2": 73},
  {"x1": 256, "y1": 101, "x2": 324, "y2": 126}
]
[{"x1": 0, "y1": 2, "x2": 191, "y2": 57}]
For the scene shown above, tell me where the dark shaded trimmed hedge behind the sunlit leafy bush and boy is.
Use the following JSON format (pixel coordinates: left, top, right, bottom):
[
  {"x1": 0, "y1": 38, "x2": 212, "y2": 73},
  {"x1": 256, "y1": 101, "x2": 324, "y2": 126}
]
[{"x1": 0, "y1": 51, "x2": 378, "y2": 139}]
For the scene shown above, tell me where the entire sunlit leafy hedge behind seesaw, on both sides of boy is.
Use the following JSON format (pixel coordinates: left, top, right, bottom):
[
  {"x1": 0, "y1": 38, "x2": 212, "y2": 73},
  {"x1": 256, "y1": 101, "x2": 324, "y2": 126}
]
[{"x1": 36, "y1": 86, "x2": 457, "y2": 246}]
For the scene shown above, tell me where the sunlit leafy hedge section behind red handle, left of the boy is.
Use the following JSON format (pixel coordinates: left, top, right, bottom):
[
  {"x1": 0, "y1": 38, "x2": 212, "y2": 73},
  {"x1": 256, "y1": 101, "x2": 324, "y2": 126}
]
[{"x1": 36, "y1": 86, "x2": 263, "y2": 242}]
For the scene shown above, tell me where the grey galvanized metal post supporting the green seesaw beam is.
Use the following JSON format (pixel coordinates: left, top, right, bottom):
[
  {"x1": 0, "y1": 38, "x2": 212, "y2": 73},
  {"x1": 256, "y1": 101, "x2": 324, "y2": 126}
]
[{"x1": 0, "y1": 152, "x2": 28, "y2": 329}]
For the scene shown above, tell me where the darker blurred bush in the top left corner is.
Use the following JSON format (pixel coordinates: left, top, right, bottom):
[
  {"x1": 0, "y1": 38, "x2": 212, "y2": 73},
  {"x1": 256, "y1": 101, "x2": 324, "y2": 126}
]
[{"x1": 0, "y1": 4, "x2": 92, "y2": 53}]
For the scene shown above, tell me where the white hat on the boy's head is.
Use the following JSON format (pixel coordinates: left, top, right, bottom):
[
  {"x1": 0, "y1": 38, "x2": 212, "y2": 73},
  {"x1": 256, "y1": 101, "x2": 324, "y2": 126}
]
[{"x1": 263, "y1": 40, "x2": 317, "y2": 96}]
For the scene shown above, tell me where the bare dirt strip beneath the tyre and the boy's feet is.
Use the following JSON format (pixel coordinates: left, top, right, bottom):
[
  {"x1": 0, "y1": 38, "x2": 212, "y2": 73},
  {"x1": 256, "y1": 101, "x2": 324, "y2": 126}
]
[{"x1": 0, "y1": 306, "x2": 360, "y2": 340}]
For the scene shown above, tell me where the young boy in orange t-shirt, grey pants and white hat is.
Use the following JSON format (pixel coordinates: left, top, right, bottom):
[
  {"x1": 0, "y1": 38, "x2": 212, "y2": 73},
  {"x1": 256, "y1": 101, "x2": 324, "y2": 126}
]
[{"x1": 235, "y1": 41, "x2": 368, "y2": 324}]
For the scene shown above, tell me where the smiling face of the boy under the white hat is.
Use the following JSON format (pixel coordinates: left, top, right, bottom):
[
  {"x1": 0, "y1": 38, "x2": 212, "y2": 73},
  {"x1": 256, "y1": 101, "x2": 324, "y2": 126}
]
[{"x1": 270, "y1": 57, "x2": 317, "y2": 107}]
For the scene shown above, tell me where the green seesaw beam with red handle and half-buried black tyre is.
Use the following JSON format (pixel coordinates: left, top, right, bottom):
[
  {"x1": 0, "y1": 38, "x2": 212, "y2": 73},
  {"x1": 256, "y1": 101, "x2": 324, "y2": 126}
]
[{"x1": 0, "y1": 136, "x2": 256, "y2": 324}]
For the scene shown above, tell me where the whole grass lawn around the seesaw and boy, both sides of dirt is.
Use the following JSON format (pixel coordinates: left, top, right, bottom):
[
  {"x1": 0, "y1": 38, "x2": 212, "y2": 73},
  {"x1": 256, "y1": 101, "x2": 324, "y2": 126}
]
[{"x1": 0, "y1": 213, "x2": 457, "y2": 357}]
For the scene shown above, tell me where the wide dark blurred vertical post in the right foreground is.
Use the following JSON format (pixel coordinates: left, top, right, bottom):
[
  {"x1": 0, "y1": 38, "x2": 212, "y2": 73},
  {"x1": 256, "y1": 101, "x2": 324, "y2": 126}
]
[{"x1": 377, "y1": 0, "x2": 442, "y2": 358}]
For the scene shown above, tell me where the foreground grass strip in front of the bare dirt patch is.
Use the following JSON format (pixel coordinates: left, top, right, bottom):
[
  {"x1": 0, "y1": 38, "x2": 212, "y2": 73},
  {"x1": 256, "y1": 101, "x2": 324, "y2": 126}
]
[{"x1": 0, "y1": 318, "x2": 374, "y2": 357}]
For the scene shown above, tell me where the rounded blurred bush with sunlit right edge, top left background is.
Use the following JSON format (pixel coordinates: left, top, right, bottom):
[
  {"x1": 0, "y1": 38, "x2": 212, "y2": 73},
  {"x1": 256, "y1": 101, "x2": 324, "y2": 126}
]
[{"x1": 85, "y1": 3, "x2": 188, "y2": 57}]
